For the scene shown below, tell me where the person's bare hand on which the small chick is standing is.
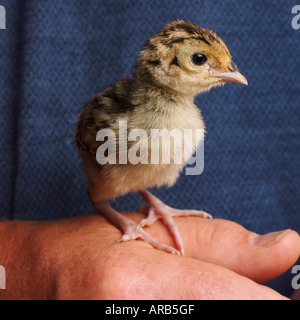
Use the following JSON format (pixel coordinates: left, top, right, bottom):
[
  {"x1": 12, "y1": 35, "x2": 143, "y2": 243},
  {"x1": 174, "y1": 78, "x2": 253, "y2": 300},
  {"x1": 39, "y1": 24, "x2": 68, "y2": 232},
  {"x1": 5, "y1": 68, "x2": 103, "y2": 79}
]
[{"x1": 0, "y1": 213, "x2": 300, "y2": 300}]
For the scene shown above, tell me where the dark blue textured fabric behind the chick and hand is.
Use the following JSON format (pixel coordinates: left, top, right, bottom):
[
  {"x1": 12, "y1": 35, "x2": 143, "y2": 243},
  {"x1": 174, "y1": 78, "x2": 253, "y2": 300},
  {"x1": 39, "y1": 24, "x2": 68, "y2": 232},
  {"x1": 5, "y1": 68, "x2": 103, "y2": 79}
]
[{"x1": 0, "y1": 0, "x2": 300, "y2": 294}]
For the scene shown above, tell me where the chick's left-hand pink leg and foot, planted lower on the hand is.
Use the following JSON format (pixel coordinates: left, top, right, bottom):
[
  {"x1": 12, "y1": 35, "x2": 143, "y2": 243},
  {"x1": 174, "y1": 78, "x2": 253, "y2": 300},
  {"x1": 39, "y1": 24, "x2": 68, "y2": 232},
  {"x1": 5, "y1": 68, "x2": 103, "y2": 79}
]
[{"x1": 92, "y1": 201, "x2": 180, "y2": 255}]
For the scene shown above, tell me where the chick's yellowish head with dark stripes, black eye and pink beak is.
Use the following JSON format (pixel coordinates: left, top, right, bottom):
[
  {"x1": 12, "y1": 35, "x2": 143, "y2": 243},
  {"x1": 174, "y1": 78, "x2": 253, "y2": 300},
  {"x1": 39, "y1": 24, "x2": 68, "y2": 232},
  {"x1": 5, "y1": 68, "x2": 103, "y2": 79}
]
[{"x1": 135, "y1": 20, "x2": 247, "y2": 96}]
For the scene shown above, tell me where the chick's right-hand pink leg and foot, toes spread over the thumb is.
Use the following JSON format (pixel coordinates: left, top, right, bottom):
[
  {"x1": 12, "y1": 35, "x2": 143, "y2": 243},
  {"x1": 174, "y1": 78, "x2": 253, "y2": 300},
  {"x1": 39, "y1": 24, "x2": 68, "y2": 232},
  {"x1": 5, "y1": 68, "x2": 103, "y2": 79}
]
[{"x1": 139, "y1": 190, "x2": 212, "y2": 255}]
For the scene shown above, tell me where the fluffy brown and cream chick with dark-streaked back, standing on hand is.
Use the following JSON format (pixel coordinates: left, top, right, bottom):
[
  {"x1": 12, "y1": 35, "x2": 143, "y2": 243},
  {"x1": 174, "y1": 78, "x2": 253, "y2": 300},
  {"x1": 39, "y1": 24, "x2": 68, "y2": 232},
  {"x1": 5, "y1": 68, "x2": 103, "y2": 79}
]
[{"x1": 76, "y1": 20, "x2": 247, "y2": 254}]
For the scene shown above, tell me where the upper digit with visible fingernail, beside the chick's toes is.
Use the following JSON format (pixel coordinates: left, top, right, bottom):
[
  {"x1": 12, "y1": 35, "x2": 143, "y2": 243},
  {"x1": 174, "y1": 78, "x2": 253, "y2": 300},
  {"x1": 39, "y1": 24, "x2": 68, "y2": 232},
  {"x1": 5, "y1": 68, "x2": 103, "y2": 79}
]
[{"x1": 128, "y1": 217, "x2": 300, "y2": 283}]
